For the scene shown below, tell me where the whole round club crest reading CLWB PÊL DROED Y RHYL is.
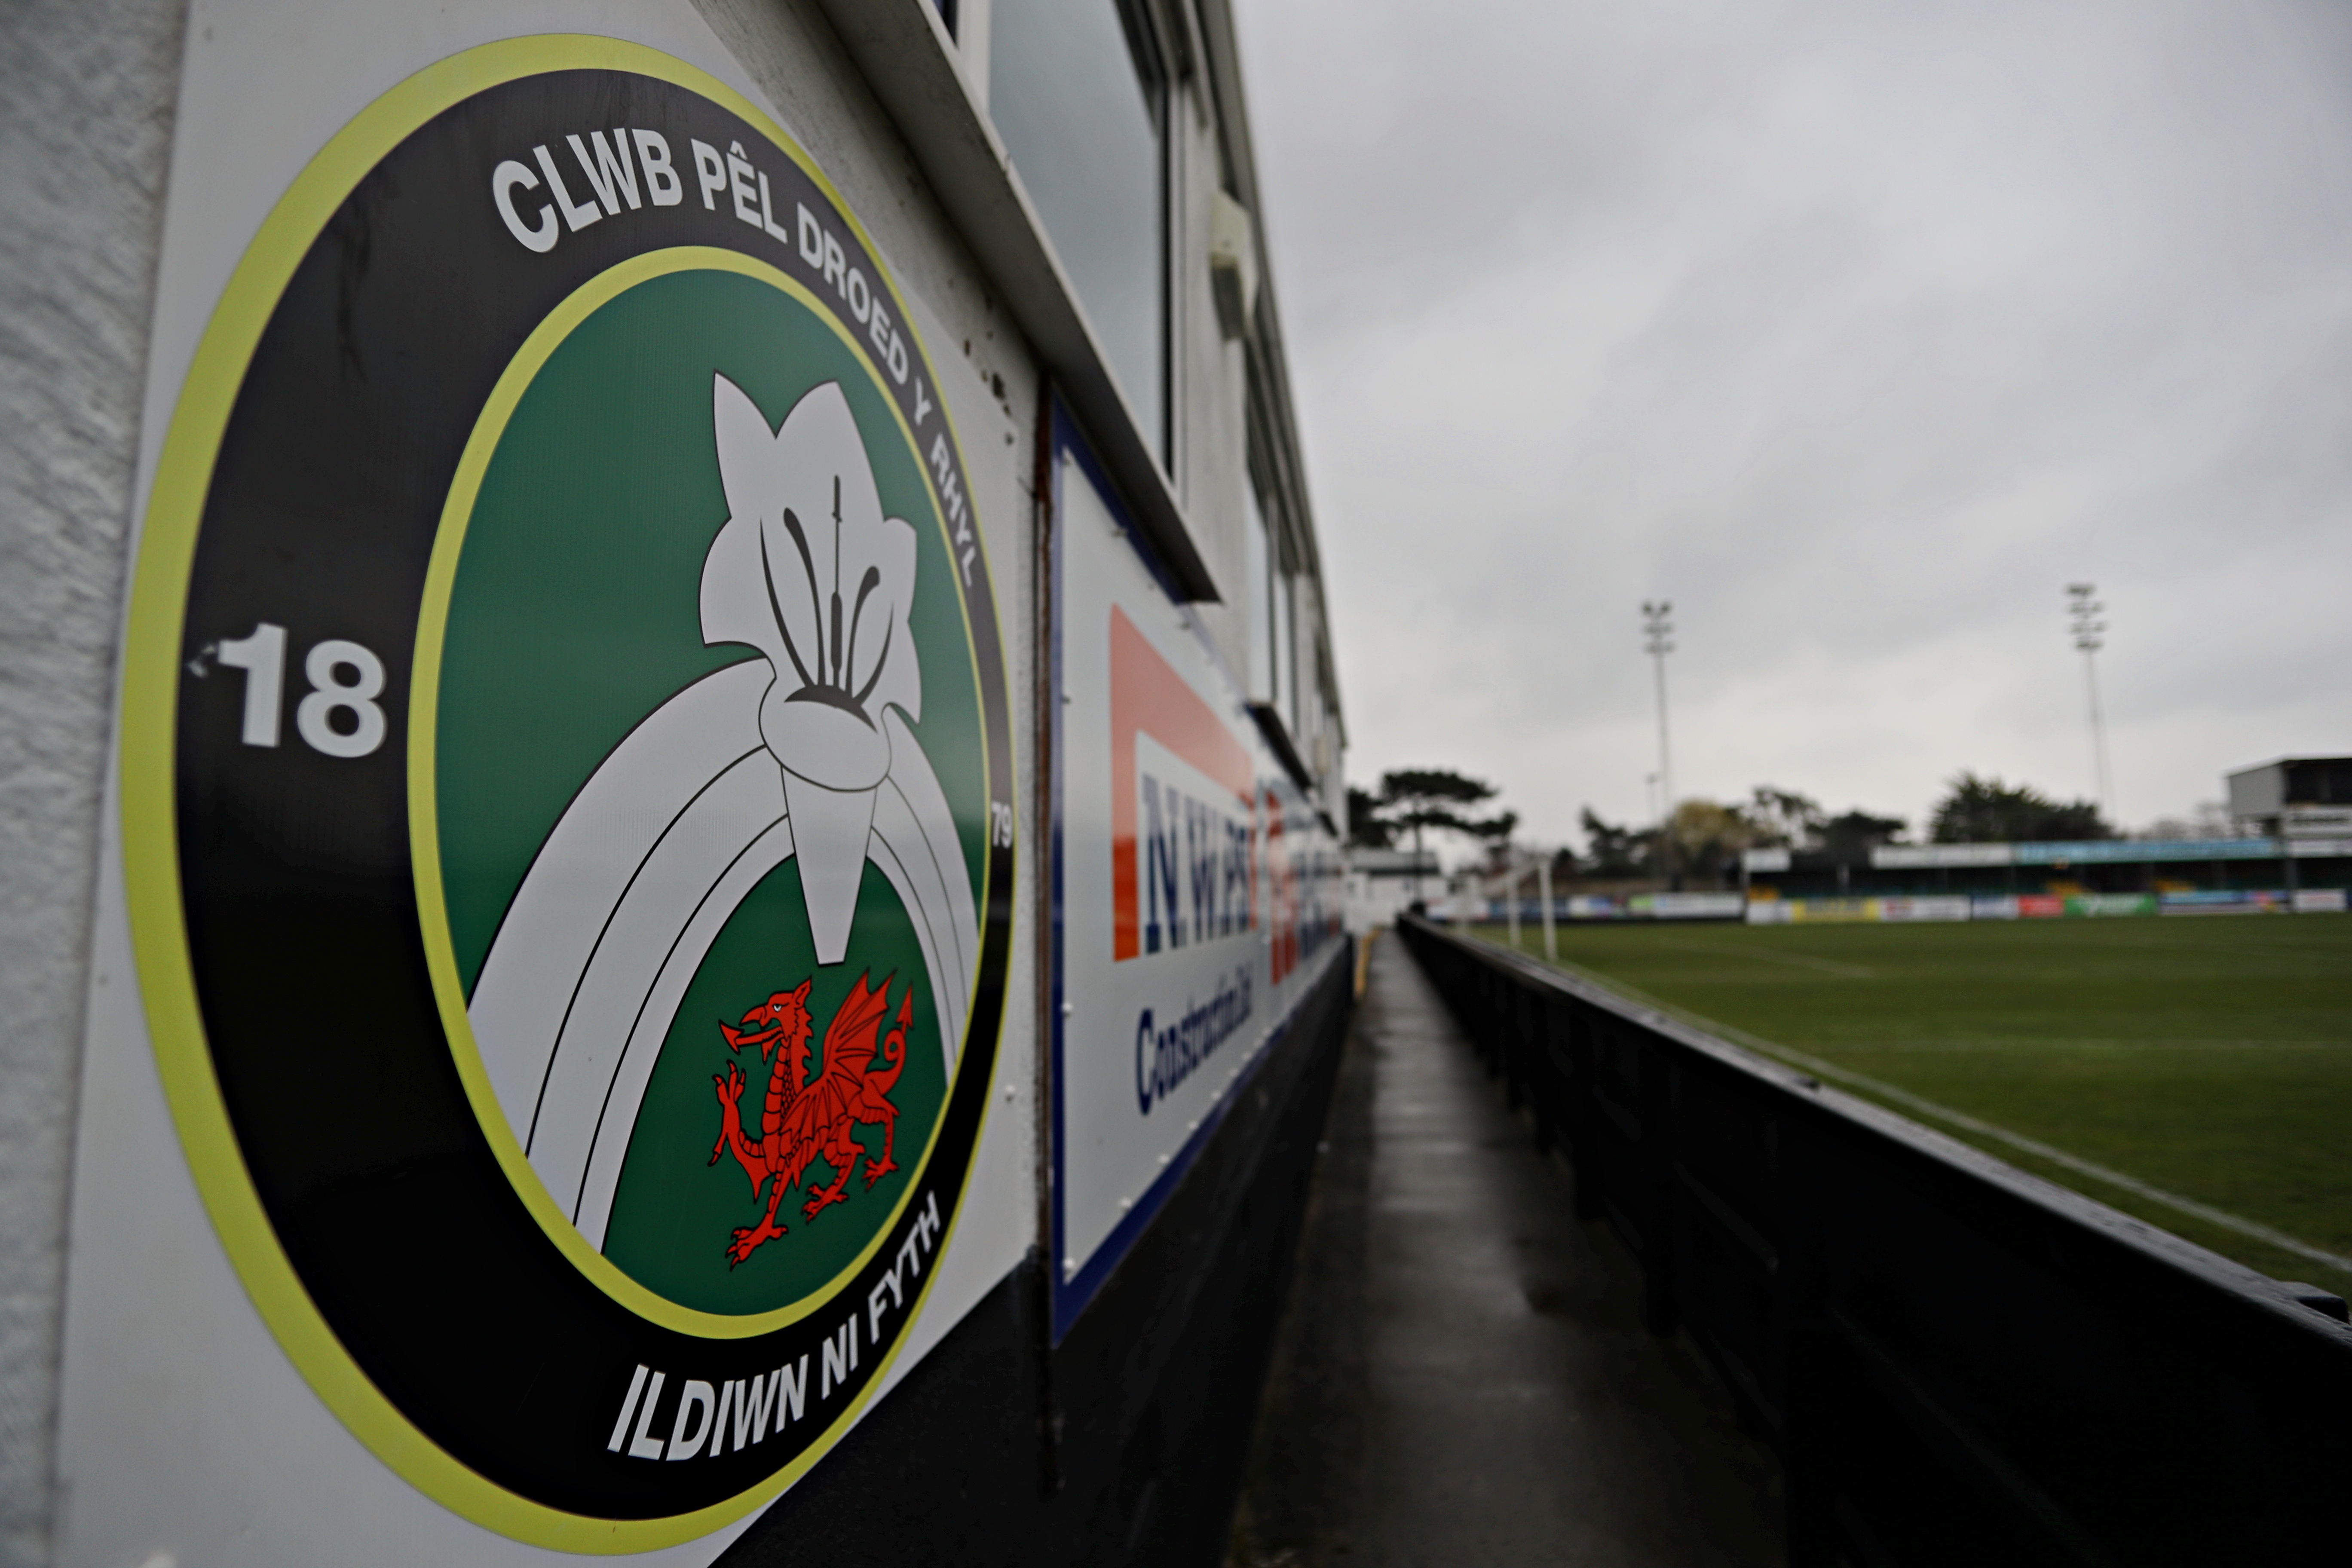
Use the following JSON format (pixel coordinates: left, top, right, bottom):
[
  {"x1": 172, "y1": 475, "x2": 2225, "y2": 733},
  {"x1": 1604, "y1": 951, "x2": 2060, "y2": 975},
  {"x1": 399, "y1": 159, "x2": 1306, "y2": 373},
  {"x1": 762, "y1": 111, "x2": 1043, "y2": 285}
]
[{"x1": 125, "y1": 35, "x2": 1014, "y2": 1552}]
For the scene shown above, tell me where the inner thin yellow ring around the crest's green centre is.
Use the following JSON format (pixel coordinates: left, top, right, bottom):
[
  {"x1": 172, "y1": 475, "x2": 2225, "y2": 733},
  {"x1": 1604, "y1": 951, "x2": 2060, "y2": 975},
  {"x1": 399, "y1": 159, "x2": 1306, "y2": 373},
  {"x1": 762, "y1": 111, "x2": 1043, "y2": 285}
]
[{"x1": 409, "y1": 245, "x2": 988, "y2": 1340}]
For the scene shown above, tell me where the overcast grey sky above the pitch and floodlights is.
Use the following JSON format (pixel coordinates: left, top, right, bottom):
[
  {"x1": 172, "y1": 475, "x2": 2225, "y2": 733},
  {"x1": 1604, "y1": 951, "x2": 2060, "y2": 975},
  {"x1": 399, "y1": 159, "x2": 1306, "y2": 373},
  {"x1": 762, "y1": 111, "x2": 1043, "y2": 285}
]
[{"x1": 1235, "y1": 0, "x2": 2352, "y2": 842}]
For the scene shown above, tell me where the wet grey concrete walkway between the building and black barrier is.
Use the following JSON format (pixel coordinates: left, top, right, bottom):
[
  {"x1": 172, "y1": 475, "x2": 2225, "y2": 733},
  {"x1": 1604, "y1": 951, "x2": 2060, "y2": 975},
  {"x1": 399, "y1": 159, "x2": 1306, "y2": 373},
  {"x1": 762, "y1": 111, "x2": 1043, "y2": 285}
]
[{"x1": 1232, "y1": 936, "x2": 1780, "y2": 1568}]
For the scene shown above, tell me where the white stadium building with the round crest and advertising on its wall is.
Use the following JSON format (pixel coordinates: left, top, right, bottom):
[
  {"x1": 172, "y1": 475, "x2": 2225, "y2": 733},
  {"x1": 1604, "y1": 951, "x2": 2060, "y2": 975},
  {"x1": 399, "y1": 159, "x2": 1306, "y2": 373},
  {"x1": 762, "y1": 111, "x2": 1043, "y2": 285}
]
[{"x1": 0, "y1": 0, "x2": 1350, "y2": 1568}]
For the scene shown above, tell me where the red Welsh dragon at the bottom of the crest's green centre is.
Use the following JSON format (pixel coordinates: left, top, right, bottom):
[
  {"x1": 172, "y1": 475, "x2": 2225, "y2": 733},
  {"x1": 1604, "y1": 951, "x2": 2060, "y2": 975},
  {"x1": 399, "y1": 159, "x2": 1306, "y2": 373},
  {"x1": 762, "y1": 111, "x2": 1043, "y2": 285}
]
[{"x1": 710, "y1": 973, "x2": 915, "y2": 1267}]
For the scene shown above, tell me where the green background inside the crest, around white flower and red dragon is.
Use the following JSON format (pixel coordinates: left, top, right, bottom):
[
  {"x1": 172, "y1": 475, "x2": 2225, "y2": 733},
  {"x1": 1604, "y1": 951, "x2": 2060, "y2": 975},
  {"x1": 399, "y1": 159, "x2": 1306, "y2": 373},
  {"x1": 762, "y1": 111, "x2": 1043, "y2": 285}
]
[{"x1": 433, "y1": 270, "x2": 988, "y2": 1314}]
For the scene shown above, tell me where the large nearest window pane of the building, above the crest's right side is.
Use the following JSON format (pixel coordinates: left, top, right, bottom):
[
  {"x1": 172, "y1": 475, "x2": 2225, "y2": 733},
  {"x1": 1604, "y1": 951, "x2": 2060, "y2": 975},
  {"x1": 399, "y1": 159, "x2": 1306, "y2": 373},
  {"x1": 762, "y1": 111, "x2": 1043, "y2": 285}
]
[{"x1": 988, "y1": 0, "x2": 1169, "y2": 463}]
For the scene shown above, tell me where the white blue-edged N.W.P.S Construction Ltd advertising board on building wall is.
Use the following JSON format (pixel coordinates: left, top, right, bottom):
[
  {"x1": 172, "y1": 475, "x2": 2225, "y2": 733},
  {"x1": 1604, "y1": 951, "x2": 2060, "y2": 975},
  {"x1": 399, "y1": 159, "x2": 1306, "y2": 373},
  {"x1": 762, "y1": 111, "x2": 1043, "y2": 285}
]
[{"x1": 1051, "y1": 409, "x2": 1345, "y2": 1338}]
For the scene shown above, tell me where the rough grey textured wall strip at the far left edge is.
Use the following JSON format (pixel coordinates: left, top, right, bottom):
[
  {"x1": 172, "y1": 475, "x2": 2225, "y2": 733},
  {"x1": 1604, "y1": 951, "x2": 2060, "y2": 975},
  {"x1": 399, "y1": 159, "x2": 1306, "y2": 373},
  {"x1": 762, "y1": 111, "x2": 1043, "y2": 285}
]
[{"x1": 0, "y1": 0, "x2": 184, "y2": 1566}]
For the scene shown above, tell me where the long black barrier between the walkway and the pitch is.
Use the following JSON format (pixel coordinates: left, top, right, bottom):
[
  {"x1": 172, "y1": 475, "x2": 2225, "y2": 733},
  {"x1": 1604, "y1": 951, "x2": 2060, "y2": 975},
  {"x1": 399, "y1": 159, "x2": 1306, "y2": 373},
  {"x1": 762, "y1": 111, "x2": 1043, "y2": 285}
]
[{"x1": 1400, "y1": 917, "x2": 2352, "y2": 1568}]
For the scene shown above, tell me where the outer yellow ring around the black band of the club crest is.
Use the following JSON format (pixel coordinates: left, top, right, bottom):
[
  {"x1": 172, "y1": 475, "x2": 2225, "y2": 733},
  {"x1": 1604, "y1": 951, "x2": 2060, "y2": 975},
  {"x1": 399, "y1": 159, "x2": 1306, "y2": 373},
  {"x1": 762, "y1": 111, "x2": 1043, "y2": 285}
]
[{"x1": 118, "y1": 33, "x2": 1016, "y2": 1554}]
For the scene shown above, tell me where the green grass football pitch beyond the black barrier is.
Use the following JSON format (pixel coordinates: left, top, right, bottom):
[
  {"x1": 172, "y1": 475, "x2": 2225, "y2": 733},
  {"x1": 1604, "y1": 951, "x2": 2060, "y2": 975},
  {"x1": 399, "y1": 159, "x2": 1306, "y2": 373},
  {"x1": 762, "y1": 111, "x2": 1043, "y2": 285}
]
[{"x1": 1482, "y1": 915, "x2": 2352, "y2": 1291}]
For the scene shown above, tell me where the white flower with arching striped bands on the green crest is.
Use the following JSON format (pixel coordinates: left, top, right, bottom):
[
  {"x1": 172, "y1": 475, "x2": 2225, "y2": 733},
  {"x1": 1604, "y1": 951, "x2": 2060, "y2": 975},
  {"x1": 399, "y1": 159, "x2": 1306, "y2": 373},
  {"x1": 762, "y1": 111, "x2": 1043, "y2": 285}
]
[{"x1": 466, "y1": 376, "x2": 978, "y2": 1246}]
